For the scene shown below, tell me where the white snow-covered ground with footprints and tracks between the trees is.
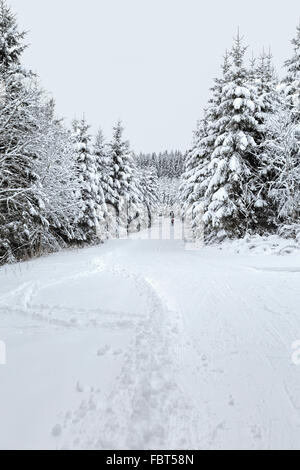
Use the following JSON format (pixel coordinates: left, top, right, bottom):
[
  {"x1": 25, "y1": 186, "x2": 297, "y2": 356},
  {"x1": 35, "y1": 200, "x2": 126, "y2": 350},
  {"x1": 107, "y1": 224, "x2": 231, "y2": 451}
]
[{"x1": 0, "y1": 220, "x2": 300, "y2": 449}]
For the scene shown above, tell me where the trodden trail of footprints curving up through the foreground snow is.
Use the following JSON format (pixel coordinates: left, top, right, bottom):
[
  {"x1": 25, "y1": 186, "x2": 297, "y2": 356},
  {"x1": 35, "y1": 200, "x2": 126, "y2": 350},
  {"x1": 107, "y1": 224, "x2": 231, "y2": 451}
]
[{"x1": 56, "y1": 265, "x2": 197, "y2": 449}]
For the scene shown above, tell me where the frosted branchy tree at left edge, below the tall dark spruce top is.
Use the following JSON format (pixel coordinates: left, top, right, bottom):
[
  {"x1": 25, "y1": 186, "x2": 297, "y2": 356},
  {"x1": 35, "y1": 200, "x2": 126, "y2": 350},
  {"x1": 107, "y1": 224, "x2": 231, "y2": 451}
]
[{"x1": 0, "y1": 81, "x2": 49, "y2": 262}]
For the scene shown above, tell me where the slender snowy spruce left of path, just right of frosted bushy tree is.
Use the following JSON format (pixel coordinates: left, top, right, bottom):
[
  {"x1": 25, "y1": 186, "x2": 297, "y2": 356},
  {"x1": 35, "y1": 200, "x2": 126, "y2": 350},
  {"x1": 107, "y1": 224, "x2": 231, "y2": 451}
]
[{"x1": 73, "y1": 118, "x2": 104, "y2": 243}]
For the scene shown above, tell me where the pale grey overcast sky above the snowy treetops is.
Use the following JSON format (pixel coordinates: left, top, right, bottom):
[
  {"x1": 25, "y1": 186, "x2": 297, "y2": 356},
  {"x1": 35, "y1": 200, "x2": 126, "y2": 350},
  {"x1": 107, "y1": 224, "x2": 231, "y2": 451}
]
[{"x1": 8, "y1": 0, "x2": 300, "y2": 152}]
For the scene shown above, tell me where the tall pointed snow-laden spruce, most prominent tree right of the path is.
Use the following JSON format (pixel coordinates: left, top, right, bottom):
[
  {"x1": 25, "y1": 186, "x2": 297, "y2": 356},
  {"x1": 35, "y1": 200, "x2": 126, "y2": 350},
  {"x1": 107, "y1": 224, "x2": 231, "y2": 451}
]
[{"x1": 203, "y1": 34, "x2": 261, "y2": 237}]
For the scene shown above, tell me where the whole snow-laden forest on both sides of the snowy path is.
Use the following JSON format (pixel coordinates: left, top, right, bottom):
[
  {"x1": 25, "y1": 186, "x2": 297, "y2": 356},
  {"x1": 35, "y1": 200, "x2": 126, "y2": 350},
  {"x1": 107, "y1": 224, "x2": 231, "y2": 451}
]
[{"x1": 0, "y1": 0, "x2": 300, "y2": 264}]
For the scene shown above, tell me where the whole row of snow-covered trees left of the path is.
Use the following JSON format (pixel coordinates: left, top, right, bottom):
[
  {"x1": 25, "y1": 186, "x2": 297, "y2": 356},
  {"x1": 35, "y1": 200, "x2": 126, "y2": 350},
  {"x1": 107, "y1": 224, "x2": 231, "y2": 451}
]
[{"x1": 0, "y1": 0, "x2": 158, "y2": 264}]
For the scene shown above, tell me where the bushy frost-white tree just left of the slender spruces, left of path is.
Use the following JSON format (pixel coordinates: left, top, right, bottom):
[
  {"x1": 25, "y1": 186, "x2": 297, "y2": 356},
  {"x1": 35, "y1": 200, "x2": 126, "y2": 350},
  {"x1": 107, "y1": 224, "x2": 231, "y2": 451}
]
[{"x1": 35, "y1": 99, "x2": 83, "y2": 250}]
